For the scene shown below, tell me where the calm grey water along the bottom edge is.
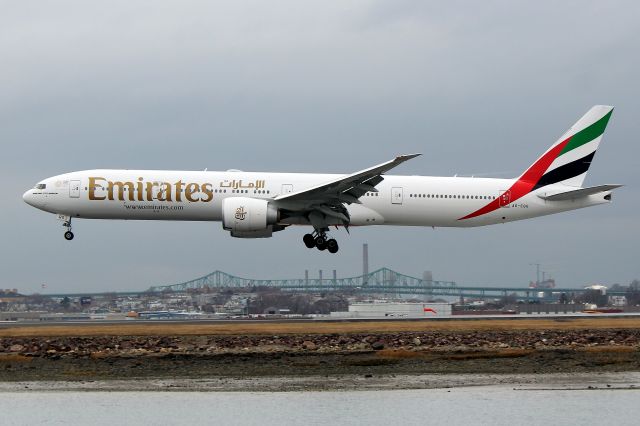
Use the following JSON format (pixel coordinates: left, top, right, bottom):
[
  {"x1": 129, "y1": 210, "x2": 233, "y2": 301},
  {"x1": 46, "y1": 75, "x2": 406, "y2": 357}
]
[{"x1": 0, "y1": 386, "x2": 640, "y2": 426}]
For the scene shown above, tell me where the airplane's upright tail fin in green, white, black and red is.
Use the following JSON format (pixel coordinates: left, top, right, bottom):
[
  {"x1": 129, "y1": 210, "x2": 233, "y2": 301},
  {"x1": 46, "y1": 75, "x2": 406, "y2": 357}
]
[{"x1": 518, "y1": 105, "x2": 613, "y2": 191}]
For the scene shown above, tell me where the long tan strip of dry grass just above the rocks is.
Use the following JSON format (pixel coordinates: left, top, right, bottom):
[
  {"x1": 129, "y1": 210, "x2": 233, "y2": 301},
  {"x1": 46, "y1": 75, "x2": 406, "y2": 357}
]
[{"x1": 0, "y1": 317, "x2": 640, "y2": 337}]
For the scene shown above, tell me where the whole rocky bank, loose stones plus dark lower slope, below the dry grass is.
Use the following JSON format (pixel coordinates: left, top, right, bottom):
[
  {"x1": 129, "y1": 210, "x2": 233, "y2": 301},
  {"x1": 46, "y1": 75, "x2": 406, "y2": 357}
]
[{"x1": 0, "y1": 328, "x2": 640, "y2": 382}]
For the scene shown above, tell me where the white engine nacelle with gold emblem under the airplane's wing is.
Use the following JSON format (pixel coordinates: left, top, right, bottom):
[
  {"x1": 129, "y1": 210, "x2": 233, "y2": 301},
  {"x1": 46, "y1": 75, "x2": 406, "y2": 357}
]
[{"x1": 222, "y1": 197, "x2": 278, "y2": 238}]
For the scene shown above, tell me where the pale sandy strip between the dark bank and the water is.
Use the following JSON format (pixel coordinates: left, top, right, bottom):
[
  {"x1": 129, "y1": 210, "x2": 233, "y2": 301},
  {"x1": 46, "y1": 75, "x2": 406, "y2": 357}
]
[{"x1": 0, "y1": 372, "x2": 640, "y2": 392}]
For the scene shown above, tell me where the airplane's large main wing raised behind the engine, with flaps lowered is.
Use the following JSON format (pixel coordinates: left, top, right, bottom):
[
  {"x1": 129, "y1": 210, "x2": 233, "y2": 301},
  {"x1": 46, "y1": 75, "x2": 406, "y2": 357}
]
[{"x1": 274, "y1": 154, "x2": 421, "y2": 228}]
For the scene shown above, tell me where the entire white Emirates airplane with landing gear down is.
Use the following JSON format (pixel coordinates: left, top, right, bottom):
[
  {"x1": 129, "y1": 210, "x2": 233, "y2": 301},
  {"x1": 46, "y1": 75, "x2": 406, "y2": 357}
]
[{"x1": 23, "y1": 105, "x2": 622, "y2": 253}]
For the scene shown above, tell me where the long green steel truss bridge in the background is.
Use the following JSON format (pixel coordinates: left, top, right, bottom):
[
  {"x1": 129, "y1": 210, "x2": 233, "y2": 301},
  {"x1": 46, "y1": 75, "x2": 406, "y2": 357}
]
[{"x1": 149, "y1": 268, "x2": 613, "y2": 300}]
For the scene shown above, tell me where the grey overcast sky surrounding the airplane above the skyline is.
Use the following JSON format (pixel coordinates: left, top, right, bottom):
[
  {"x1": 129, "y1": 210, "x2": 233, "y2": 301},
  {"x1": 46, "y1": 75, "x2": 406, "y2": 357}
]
[{"x1": 0, "y1": 0, "x2": 640, "y2": 293}]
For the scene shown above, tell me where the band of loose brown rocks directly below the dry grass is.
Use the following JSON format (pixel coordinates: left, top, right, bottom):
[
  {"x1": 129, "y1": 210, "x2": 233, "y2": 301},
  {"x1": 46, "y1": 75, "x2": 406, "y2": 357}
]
[{"x1": 0, "y1": 329, "x2": 640, "y2": 359}]
